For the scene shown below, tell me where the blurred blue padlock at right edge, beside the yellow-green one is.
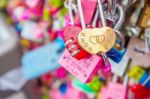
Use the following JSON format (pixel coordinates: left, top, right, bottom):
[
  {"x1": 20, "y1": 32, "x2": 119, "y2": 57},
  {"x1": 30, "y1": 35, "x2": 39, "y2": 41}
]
[{"x1": 139, "y1": 71, "x2": 150, "y2": 88}]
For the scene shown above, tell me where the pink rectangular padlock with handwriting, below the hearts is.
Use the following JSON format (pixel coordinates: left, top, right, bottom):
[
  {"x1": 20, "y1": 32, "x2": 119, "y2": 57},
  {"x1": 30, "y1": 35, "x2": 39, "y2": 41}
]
[{"x1": 59, "y1": 50, "x2": 103, "y2": 83}]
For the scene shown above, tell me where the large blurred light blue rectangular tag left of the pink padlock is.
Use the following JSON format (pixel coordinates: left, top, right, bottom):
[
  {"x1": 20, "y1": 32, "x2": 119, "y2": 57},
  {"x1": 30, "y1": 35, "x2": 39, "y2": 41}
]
[{"x1": 22, "y1": 38, "x2": 64, "y2": 79}]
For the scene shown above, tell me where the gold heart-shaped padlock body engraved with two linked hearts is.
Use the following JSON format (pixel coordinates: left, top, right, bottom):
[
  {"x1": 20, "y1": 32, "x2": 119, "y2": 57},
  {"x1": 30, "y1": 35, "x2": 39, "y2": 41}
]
[{"x1": 78, "y1": 27, "x2": 116, "y2": 54}]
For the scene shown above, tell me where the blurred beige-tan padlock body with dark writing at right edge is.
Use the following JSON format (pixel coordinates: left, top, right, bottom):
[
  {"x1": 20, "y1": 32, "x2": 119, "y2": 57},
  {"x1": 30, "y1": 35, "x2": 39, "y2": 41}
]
[{"x1": 127, "y1": 37, "x2": 150, "y2": 68}]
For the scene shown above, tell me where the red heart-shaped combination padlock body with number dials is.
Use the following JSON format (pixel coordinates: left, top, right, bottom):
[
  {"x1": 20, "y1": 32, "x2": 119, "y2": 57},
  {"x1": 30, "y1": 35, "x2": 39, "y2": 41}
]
[{"x1": 63, "y1": 26, "x2": 89, "y2": 59}]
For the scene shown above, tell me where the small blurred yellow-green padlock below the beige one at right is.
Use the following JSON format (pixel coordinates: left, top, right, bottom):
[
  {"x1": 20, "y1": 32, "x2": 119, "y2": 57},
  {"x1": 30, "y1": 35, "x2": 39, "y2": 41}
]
[{"x1": 128, "y1": 66, "x2": 144, "y2": 81}]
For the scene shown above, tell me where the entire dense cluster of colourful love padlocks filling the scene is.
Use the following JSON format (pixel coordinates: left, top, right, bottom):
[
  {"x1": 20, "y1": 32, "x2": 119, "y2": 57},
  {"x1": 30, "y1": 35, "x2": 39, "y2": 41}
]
[{"x1": 0, "y1": 0, "x2": 150, "y2": 99}]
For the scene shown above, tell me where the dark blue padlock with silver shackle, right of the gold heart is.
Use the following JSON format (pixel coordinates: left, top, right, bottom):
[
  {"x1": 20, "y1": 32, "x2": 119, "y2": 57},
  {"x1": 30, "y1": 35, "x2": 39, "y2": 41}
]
[{"x1": 107, "y1": 5, "x2": 127, "y2": 63}]
